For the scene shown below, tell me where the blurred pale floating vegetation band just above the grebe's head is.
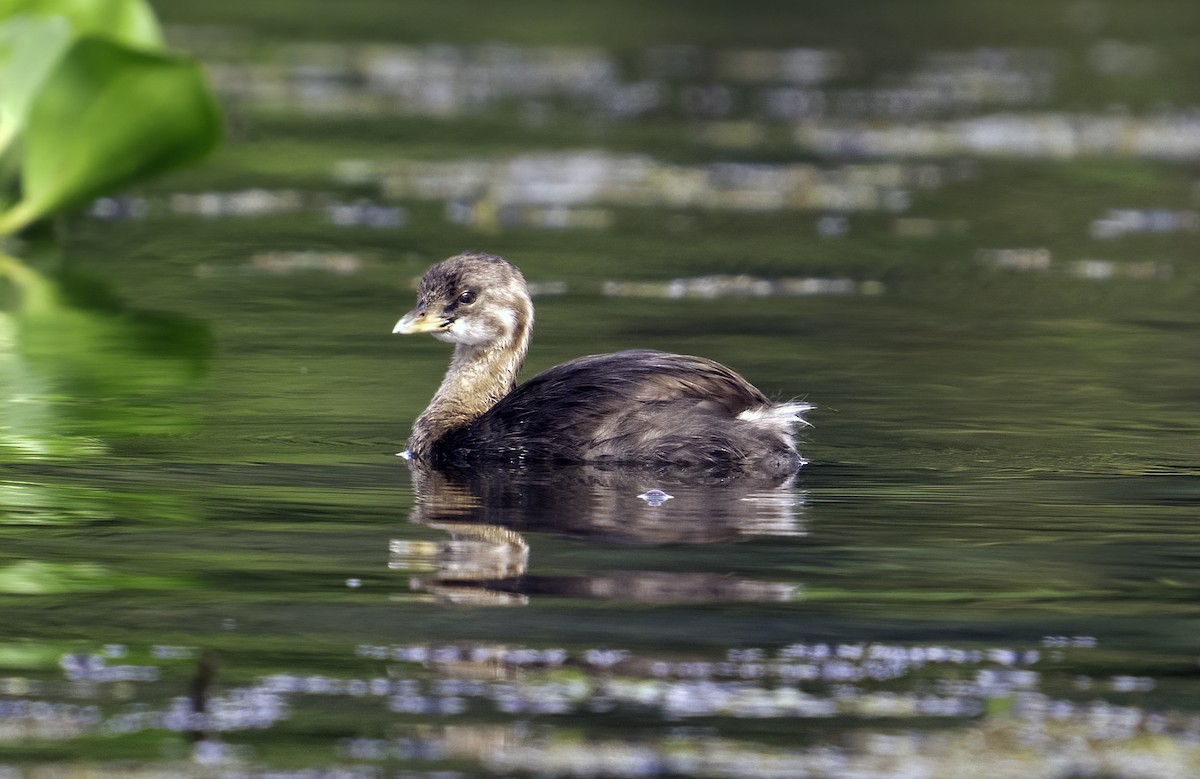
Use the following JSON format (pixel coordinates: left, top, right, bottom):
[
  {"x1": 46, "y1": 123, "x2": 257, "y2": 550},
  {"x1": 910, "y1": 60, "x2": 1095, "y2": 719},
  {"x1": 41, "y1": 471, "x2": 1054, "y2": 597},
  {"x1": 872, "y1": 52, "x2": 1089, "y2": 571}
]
[{"x1": 89, "y1": 151, "x2": 948, "y2": 234}]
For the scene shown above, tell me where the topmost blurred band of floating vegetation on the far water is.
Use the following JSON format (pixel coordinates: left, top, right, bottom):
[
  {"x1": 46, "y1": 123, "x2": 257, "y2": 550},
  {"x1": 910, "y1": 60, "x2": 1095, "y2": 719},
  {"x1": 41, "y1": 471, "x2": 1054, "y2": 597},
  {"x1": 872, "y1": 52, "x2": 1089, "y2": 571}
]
[{"x1": 172, "y1": 37, "x2": 1060, "y2": 122}]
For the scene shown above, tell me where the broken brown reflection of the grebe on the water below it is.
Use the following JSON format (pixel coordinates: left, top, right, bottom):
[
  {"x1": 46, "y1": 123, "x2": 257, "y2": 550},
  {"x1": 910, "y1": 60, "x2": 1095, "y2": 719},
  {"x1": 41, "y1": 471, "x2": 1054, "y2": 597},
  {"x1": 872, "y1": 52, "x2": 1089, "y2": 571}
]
[{"x1": 389, "y1": 462, "x2": 804, "y2": 606}]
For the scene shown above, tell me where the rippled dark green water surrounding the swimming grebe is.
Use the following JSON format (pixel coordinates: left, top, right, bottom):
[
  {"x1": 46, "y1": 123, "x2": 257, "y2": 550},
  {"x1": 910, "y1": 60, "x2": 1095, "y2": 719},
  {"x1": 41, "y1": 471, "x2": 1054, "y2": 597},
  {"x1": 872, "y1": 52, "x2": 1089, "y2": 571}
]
[{"x1": 0, "y1": 4, "x2": 1200, "y2": 779}]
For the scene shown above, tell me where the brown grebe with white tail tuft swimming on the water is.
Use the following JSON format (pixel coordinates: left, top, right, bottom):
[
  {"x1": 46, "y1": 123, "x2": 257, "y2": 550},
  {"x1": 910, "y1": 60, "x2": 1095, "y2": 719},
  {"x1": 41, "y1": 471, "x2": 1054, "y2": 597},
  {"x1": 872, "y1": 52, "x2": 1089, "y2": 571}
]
[{"x1": 392, "y1": 253, "x2": 812, "y2": 473}]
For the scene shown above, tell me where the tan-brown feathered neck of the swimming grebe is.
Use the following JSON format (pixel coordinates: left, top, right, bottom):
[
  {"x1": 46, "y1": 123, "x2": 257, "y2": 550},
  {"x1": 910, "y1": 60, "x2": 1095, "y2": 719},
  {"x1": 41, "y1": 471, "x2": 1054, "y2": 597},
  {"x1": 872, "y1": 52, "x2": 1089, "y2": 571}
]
[{"x1": 408, "y1": 326, "x2": 529, "y2": 459}]
